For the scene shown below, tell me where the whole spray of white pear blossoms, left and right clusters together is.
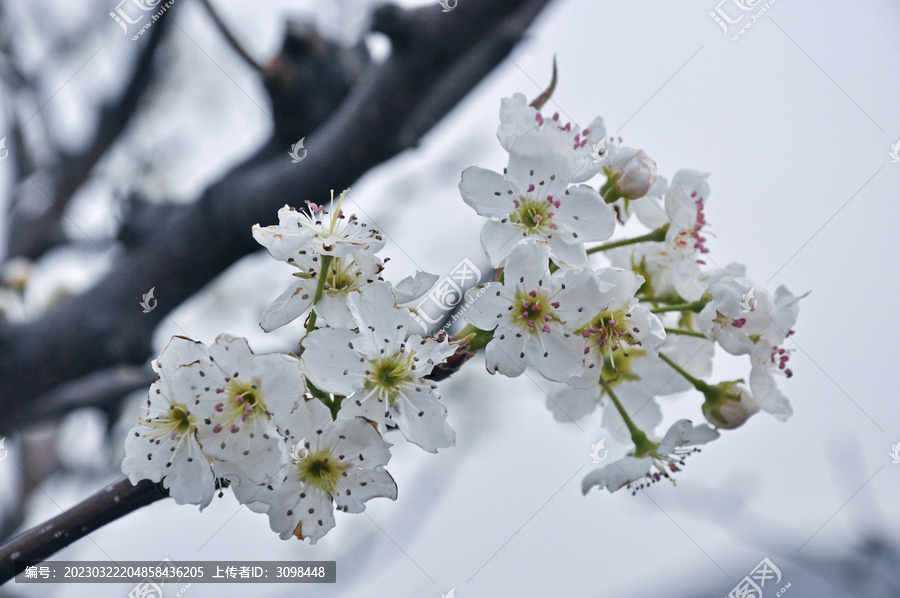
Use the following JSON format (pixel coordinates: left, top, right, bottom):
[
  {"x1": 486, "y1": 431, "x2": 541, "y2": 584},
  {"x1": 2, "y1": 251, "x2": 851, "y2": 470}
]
[{"x1": 122, "y1": 78, "x2": 802, "y2": 543}]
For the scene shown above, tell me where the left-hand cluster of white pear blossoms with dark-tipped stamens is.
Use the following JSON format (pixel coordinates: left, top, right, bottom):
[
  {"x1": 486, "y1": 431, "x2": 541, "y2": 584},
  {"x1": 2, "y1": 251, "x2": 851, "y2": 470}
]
[{"x1": 122, "y1": 192, "x2": 457, "y2": 544}]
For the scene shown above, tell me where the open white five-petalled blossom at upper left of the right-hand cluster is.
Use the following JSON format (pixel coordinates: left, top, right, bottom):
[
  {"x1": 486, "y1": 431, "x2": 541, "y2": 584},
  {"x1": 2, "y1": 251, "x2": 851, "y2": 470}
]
[{"x1": 459, "y1": 107, "x2": 615, "y2": 269}]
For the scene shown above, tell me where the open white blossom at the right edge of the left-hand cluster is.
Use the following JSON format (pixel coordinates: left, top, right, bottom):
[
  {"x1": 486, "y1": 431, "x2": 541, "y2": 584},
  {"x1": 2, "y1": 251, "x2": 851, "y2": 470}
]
[{"x1": 301, "y1": 284, "x2": 456, "y2": 452}]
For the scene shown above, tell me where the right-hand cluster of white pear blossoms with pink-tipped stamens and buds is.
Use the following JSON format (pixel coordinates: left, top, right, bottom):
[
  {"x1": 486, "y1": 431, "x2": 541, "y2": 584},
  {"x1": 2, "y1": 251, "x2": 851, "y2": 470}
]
[{"x1": 459, "y1": 95, "x2": 800, "y2": 492}]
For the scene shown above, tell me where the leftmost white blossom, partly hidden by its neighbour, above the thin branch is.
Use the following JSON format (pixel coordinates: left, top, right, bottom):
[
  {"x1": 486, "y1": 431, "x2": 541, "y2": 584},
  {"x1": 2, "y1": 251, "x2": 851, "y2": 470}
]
[{"x1": 122, "y1": 336, "x2": 216, "y2": 509}]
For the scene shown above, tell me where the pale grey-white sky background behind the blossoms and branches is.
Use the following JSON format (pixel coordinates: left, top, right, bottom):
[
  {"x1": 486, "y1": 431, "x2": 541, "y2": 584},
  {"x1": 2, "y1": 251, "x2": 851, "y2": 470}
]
[{"x1": 0, "y1": 0, "x2": 900, "y2": 598}]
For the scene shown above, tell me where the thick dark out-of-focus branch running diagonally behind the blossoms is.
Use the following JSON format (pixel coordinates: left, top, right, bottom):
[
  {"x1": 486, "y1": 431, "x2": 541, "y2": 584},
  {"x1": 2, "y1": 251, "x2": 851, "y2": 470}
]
[{"x1": 0, "y1": 0, "x2": 549, "y2": 428}]
